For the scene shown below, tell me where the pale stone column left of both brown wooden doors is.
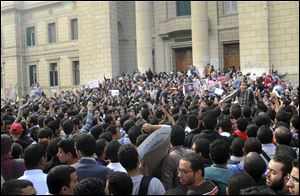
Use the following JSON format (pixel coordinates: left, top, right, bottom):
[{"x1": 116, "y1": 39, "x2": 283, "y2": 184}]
[{"x1": 135, "y1": 1, "x2": 153, "y2": 73}]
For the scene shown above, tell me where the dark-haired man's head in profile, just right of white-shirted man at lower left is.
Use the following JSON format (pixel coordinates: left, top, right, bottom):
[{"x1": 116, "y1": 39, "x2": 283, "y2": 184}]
[{"x1": 57, "y1": 139, "x2": 77, "y2": 165}]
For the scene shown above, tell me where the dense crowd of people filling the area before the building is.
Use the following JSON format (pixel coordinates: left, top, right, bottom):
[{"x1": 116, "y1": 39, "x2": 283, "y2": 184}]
[{"x1": 1, "y1": 66, "x2": 299, "y2": 195}]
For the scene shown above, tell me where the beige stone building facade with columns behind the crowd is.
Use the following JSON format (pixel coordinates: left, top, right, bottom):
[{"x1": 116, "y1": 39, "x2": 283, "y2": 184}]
[{"x1": 1, "y1": 1, "x2": 299, "y2": 95}]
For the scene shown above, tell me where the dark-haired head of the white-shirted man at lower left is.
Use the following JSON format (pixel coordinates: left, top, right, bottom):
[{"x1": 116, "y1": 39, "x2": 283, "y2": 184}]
[{"x1": 24, "y1": 144, "x2": 47, "y2": 170}]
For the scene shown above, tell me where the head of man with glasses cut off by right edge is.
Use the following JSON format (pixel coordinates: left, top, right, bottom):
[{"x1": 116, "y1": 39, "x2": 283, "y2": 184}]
[{"x1": 286, "y1": 159, "x2": 299, "y2": 195}]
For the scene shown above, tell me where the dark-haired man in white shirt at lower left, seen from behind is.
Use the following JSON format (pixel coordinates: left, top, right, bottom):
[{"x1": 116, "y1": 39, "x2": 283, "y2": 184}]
[{"x1": 18, "y1": 144, "x2": 48, "y2": 195}]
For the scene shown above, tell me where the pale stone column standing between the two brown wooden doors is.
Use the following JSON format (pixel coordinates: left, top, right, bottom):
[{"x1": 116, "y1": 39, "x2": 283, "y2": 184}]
[{"x1": 191, "y1": 1, "x2": 209, "y2": 75}]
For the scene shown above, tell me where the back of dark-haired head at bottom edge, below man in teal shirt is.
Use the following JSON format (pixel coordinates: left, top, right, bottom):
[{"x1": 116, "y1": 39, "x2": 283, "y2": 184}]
[{"x1": 226, "y1": 171, "x2": 255, "y2": 195}]
